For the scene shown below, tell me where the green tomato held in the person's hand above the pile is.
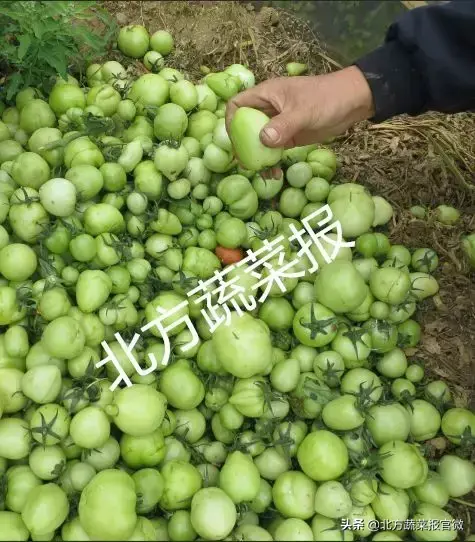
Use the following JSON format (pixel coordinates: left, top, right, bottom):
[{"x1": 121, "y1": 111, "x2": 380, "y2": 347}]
[{"x1": 230, "y1": 107, "x2": 284, "y2": 171}]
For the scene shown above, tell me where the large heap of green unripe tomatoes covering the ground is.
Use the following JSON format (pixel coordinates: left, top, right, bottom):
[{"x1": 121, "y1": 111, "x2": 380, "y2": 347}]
[{"x1": 0, "y1": 26, "x2": 475, "y2": 541}]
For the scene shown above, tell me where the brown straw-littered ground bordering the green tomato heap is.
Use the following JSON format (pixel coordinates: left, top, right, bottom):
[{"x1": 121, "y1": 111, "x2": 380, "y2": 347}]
[{"x1": 103, "y1": 1, "x2": 475, "y2": 532}]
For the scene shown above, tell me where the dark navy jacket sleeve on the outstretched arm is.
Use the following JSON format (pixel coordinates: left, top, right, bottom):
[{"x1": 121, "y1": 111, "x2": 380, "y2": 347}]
[{"x1": 355, "y1": 0, "x2": 475, "y2": 122}]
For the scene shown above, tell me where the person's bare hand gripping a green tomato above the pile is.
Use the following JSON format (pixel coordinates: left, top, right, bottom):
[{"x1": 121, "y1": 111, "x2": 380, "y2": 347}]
[{"x1": 226, "y1": 66, "x2": 374, "y2": 148}]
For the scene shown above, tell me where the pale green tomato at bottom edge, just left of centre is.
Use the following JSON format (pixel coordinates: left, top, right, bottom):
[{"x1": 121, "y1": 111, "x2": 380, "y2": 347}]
[{"x1": 191, "y1": 487, "x2": 237, "y2": 540}]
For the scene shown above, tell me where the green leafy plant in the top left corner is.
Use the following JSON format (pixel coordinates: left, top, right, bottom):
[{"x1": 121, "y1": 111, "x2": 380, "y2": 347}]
[{"x1": 0, "y1": 1, "x2": 116, "y2": 100}]
